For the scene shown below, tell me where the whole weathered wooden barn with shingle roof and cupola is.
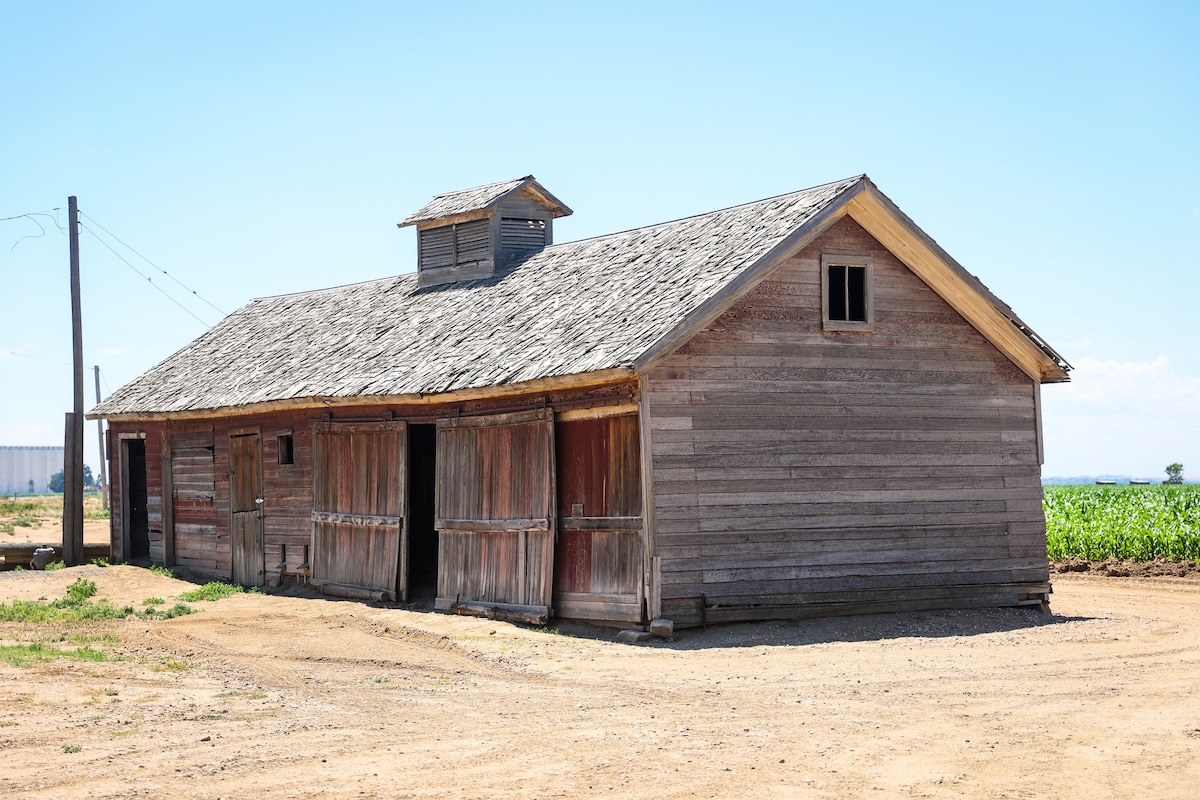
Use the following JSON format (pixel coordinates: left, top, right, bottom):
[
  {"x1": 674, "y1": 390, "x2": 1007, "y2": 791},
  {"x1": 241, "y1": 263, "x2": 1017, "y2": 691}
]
[{"x1": 89, "y1": 176, "x2": 1069, "y2": 625}]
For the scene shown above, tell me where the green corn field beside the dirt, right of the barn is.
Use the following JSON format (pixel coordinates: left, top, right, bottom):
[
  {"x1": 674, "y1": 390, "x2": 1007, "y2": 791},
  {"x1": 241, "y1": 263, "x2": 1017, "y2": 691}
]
[{"x1": 1043, "y1": 485, "x2": 1200, "y2": 561}]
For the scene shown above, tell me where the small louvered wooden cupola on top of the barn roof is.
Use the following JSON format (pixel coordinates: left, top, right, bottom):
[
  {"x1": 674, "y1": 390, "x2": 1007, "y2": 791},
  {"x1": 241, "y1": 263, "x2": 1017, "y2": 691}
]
[{"x1": 400, "y1": 175, "x2": 571, "y2": 287}]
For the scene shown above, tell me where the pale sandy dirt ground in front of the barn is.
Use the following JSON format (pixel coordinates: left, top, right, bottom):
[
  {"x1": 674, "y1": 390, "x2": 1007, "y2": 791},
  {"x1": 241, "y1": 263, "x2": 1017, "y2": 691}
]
[{"x1": 0, "y1": 566, "x2": 1200, "y2": 799}]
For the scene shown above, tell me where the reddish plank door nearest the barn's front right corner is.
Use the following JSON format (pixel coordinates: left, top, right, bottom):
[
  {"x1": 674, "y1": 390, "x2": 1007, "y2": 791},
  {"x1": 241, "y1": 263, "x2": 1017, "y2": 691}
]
[{"x1": 554, "y1": 415, "x2": 644, "y2": 622}]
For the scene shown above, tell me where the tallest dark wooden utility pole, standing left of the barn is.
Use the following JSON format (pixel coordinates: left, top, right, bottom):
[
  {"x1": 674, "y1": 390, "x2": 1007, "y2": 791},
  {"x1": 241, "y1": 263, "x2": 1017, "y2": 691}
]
[{"x1": 62, "y1": 197, "x2": 83, "y2": 566}]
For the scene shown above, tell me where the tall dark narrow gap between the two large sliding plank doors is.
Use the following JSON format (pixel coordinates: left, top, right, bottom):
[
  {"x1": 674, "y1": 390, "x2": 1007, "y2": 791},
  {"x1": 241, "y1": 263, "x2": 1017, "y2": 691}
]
[{"x1": 408, "y1": 425, "x2": 438, "y2": 602}]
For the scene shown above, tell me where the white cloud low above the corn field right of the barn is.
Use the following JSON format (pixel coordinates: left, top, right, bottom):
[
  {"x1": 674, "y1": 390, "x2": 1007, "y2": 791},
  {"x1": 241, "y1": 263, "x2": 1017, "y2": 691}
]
[{"x1": 1042, "y1": 356, "x2": 1200, "y2": 477}]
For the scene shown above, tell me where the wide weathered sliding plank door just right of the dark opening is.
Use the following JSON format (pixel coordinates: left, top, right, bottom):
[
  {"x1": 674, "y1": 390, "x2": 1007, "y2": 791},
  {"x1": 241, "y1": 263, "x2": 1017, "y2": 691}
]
[{"x1": 434, "y1": 409, "x2": 556, "y2": 622}]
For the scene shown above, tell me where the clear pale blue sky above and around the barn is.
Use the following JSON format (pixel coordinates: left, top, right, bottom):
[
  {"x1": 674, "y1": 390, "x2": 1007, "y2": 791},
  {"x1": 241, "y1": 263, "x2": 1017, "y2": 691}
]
[{"x1": 0, "y1": 1, "x2": 1200, "y2": 477}]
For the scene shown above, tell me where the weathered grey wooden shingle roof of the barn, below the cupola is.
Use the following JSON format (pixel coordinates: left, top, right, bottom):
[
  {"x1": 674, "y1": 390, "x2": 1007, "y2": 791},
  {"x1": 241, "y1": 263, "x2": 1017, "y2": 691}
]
[{"x1": 89, "y1": 176, "x2": 1066, "y2": 417}]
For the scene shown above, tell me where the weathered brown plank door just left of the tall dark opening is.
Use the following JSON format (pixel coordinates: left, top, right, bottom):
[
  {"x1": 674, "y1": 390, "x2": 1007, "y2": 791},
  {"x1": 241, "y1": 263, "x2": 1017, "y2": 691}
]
[{"x1": 311, "y1": 422, "x2": 408, "y2": 600}]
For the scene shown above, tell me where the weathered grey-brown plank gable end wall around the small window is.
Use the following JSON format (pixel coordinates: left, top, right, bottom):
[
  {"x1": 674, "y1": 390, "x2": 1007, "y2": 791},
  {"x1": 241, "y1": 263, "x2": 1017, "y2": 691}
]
[{"x1": 647, "y1": 218, "x2": 1048, "y2": 622}]
